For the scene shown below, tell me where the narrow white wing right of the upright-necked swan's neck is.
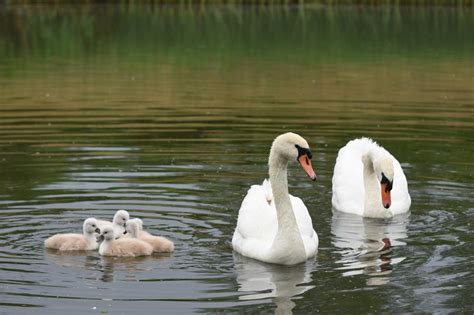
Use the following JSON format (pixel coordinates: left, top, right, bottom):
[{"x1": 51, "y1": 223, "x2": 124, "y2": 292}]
[{"x1": 290, "y1": 195, "x2": 319, "y2": 258}]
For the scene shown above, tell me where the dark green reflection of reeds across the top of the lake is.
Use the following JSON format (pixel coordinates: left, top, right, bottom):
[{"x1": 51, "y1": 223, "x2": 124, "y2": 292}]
[{"x1": 0, "y1": 3, "x2": 474, "y2": 64}]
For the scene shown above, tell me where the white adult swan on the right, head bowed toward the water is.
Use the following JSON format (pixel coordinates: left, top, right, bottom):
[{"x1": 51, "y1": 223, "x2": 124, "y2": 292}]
[{"x1": 332, "y1": 138, "x2": 411, "y2": 218}]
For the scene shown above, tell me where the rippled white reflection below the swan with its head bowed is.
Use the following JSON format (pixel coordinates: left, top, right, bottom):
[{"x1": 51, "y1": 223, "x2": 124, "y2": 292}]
[{"x1": 331, "y1": 210, "x2": 409, "y2": 285}]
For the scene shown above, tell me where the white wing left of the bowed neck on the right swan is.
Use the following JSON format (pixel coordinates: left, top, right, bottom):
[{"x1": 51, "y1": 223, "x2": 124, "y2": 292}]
[{"x1": 332, "y1": 141, "x2": 365, "y2": 215}]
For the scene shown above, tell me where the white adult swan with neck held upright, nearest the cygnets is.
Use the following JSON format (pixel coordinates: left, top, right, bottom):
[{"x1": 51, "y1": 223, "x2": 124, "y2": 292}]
[{"x1": 232, "y1": 132, "x2": 318, "y2": 265}]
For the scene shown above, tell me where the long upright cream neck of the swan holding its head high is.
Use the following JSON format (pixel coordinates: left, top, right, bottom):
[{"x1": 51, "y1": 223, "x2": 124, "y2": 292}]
[{"x1": 269, "y1": 152, "x2": 305, "y2": 259}]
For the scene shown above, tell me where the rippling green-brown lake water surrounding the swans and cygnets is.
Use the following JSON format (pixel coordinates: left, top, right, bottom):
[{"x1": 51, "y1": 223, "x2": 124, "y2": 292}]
[{"x1": 0, "y1": 5, "x2": 474, "y2": 314}]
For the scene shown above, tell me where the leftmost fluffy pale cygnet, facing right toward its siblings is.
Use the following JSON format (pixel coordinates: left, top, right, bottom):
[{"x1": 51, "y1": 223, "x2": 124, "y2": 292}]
[{"x1": 44, "y1": 218, "x2": 100, "y2": 250}]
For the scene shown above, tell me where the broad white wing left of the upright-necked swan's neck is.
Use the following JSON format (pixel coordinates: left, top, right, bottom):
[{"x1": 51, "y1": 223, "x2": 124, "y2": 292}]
[{"x1": 232, "y1": 185, "x2": 278, "y2": 259}]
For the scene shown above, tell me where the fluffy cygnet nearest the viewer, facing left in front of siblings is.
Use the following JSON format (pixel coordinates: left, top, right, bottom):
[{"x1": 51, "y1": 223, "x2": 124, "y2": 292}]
[{"x1": 97, "y1": 227, "x2": 153, "y2": 257}]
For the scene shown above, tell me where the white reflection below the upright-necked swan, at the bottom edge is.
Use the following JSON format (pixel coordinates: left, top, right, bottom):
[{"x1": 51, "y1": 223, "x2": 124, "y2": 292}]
[{"x1": 234, "y1": 252, "x2": 316, "y2": 314}]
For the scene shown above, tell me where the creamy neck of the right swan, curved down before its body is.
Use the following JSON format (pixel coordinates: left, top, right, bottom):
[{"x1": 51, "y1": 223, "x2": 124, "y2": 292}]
[{"x1": 362, "y1": 151, "x2": 386, "y2": 217}]
